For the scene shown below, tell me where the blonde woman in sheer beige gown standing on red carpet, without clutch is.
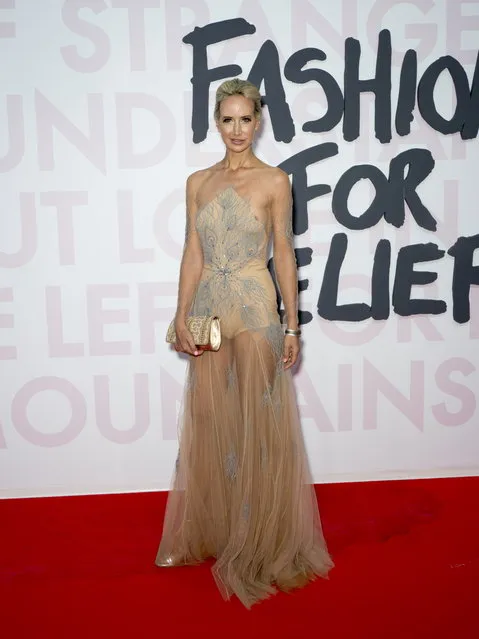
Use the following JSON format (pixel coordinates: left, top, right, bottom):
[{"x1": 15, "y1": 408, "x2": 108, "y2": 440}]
[{"x1": 156, "y1": 79, "x2": 333, "y2": 607}]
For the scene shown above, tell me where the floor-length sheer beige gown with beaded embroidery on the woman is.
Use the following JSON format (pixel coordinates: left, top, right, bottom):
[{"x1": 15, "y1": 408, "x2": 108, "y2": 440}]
[{"x1": 156, "y1": 187, "x2": 333, "y2": 607}]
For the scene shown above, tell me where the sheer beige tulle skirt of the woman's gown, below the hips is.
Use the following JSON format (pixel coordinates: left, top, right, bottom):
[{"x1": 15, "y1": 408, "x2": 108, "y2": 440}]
[{"x1": 156, "y1": 325, "x2": 333, "y2": 607}]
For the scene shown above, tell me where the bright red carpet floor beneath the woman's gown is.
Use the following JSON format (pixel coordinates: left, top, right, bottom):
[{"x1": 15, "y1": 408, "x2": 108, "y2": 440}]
[{"x1": 0, "y1": 477, "x2": 479, "y2": 639}]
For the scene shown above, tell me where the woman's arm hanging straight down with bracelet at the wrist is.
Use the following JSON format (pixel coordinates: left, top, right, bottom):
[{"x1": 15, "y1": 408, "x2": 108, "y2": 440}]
[{"x1": 271, "y1": 171, "x2": 299, "y2": 369}]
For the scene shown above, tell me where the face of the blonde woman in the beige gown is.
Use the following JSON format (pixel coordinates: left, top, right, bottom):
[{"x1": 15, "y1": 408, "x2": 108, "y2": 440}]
[{"x1": 216, "y1": 95, "x2": 259, "y2": 153}]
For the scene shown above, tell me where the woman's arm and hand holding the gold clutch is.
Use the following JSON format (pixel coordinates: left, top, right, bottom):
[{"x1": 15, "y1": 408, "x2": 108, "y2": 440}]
[{"x1": 175, "y1": 173, "x2": 203, "y2": 355}]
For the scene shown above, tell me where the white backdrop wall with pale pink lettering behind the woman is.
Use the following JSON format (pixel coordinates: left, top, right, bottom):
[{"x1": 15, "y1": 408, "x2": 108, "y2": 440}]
[{"x1": 0, "y1": 0, "x2": 479, "y2": 497}]
